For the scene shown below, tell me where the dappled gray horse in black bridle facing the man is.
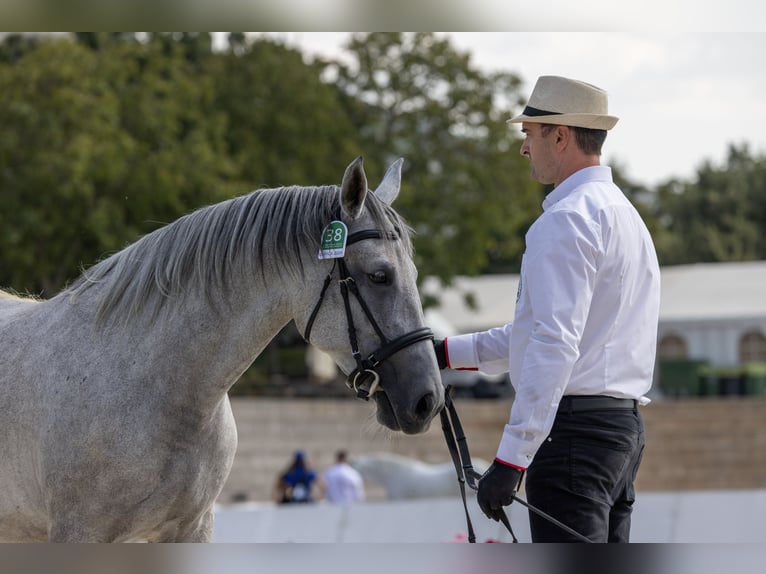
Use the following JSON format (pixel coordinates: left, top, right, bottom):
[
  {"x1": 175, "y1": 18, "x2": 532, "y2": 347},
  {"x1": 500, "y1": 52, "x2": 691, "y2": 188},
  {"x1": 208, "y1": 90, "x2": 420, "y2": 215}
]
[{"x1": 0, "y1": 158, "x2": 443, "y2": 542}]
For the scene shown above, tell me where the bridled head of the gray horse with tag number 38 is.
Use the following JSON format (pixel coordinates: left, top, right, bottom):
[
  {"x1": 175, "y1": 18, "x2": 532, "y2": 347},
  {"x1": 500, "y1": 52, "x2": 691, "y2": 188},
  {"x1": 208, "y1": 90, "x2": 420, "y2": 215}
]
[{"x1": 295, "y1": 157, "x2": 444, "y2": 434}]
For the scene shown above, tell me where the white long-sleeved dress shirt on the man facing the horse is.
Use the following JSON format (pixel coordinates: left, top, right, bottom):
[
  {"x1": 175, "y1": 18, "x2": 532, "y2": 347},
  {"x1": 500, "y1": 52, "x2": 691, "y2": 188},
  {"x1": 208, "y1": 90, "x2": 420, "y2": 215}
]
[{"x1": 446, "y1": 166, "x2": 660, "y2": 468}]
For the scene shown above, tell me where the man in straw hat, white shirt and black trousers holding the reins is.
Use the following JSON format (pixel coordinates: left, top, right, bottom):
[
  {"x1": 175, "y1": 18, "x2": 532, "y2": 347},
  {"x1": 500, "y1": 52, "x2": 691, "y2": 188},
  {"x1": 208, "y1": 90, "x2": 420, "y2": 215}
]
[{"x1": 435, "y1": 76, "x2": 660, "y2": 542}]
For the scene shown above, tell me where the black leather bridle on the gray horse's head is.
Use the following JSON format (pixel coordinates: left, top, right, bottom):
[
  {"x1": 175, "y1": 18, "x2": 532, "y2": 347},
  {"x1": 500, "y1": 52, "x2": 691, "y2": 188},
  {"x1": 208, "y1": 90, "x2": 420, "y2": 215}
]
[{"x1": 303, "y1": 229, "x2": 434, "y2": 400}]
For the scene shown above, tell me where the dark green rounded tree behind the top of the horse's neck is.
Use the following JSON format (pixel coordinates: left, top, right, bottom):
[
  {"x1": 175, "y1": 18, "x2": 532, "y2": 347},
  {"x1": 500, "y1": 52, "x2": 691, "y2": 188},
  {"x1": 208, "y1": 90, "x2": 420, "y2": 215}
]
[{"x1": 216, "y1": 35, "x2": 362, "y2": 188}]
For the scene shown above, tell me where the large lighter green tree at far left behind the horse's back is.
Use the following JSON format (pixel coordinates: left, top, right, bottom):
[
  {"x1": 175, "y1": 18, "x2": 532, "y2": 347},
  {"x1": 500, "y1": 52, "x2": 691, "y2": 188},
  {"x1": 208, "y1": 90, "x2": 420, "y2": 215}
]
[{"x1": 0, "y1": 35, "x2": 233, "y2": 296}]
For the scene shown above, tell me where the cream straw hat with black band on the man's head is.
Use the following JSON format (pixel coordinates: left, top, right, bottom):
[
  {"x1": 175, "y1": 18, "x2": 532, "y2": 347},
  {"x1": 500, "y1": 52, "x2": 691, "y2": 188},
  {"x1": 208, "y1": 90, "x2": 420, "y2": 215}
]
[{"x1": 508, "y1": 76, "x2": 618, "y2": 130}]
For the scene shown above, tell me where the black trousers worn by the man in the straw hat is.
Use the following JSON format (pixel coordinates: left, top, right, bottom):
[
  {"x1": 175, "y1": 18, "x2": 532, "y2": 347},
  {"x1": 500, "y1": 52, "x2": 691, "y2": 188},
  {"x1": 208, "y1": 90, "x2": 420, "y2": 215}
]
[{"x1": 525, "y1": 401, "x2": 645, "y2": 542}]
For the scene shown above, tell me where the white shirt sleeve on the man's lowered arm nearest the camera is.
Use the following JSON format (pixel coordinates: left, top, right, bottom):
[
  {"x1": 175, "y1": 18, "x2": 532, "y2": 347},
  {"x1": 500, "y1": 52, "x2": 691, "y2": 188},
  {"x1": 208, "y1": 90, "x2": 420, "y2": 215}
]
[{"x1": 497, "y1": 210, "x2": 600, "y2": 468}]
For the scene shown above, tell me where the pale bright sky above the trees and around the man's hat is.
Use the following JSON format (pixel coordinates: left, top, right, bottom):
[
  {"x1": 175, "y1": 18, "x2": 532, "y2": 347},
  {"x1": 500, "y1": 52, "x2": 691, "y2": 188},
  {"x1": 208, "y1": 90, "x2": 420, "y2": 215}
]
[{"x1": 252, "y1": 30, "x2": 766, "y2": 187}]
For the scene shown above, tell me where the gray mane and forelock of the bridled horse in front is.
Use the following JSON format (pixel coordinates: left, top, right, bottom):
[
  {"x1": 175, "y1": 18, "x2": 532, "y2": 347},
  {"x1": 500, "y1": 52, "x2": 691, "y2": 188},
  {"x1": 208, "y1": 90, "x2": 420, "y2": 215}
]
[{"x1": 67, "y1": 186, "x2": 412, "y2": 322}]
